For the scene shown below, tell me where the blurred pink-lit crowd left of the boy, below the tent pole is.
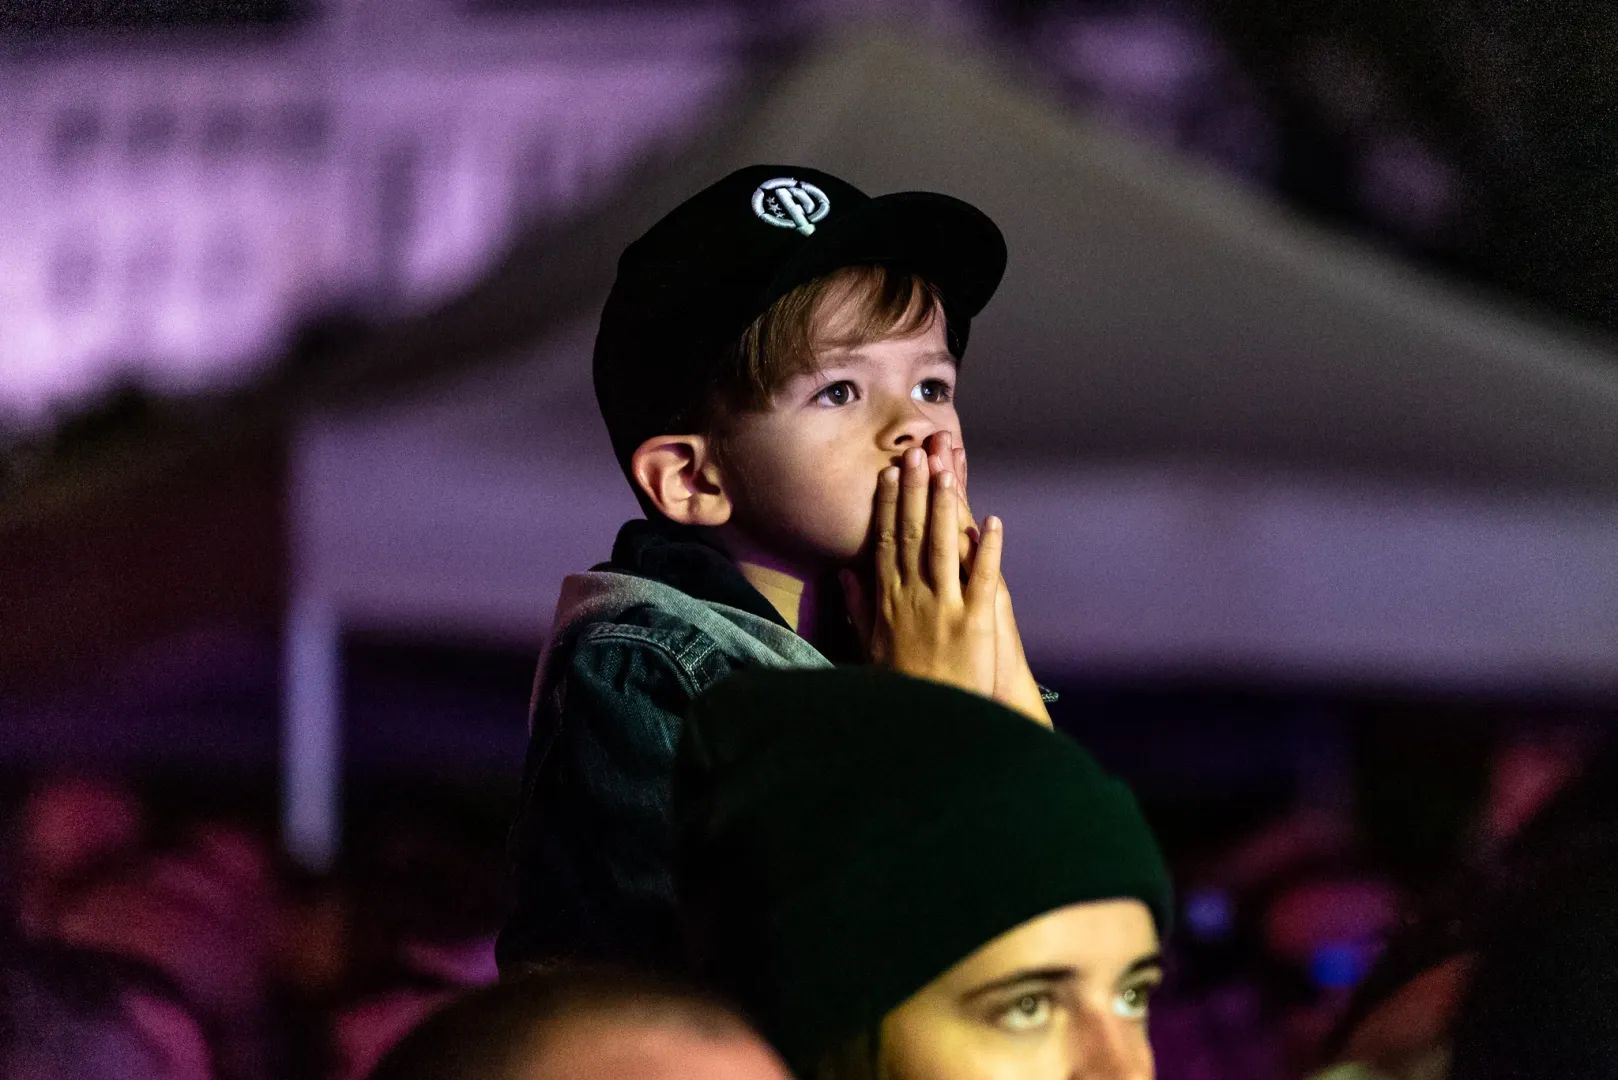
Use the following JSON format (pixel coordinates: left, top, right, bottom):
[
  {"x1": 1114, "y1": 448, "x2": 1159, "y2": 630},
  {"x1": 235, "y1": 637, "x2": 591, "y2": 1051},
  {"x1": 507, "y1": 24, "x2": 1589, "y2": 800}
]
[{"x1": 0, "y1": 776, "x2": 506, "y2": 1080}]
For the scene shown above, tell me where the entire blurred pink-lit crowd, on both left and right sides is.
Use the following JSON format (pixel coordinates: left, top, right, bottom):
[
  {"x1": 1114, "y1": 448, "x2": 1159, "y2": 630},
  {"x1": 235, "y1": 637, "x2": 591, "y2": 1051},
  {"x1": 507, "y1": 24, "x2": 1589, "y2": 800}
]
[{"x1": 0, "y1": 719, "x2": 1618, "y2": 1080}]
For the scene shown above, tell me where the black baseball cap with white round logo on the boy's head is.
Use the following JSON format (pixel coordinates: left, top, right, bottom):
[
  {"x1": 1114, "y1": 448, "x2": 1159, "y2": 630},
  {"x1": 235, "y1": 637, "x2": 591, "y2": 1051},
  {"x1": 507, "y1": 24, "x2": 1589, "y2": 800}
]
[{"x1": 594, "y1": 165, "x2": 1006, "y2": 473}]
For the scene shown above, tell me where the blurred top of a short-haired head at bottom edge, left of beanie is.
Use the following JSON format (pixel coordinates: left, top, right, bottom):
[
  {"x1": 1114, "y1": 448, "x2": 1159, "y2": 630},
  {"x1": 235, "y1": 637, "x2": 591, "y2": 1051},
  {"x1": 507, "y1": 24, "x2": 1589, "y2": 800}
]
[{"x1": 371, "y1": 967, "x2": 788, "y2": 1080}]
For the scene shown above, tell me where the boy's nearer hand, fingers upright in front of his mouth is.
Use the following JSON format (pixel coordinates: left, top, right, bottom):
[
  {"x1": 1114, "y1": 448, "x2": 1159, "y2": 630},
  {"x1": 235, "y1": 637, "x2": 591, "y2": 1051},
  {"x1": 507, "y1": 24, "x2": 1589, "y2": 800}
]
[{"x1": 841, "y1": 447, "x2": 1003, "y2": 696}]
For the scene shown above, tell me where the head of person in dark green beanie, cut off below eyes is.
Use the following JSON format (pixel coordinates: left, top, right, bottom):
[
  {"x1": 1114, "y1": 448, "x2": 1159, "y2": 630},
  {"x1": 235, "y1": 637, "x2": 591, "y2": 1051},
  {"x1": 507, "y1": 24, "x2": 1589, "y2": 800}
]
[{"x1": 675, "y1": 669, "x2": 1170, "y2": 1080}]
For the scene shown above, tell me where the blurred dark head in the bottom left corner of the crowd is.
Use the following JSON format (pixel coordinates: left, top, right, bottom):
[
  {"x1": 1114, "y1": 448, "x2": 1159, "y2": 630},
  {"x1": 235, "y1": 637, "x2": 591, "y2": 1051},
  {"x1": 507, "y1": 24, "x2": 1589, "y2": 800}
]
[{"x1": 0, "y1": 941, "x2": 214, "y2": 1080}]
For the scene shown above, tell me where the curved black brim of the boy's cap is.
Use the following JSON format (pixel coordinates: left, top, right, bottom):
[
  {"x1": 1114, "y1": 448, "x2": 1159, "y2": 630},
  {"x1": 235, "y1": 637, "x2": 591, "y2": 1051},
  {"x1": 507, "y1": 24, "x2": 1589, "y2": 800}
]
[{"x1": 765, "y1": 191, "x2": 1006, "y2": 319}]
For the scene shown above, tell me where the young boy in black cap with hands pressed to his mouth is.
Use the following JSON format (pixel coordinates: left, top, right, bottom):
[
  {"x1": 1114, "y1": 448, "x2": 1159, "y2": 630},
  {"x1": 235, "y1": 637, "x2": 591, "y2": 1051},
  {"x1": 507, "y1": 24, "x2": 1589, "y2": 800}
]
[{"x1": 500, "y1": 165, "x2": 1050, "y2": 970}]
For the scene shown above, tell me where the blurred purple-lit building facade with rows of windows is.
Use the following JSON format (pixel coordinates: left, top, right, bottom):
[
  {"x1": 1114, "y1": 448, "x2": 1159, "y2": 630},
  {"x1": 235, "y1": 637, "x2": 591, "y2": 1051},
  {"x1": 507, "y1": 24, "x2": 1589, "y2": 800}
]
[{"x1": 0, "y1": 0, "x2": 743, "y2": 424}]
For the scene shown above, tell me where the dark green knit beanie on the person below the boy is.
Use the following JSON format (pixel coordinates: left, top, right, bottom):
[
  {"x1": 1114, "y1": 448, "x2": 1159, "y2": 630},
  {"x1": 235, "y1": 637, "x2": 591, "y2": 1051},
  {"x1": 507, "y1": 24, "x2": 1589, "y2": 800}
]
[{"x1": 675, "y1": 667, "x2": 1170, "y2": 1074}]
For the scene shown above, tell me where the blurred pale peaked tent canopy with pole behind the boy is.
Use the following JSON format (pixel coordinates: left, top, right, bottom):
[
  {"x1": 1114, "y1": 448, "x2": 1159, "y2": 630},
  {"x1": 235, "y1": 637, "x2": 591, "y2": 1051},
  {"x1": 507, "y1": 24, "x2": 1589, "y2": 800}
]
[{"x1": 288, "y1": 36, "x2": 1618, "y2": 860}]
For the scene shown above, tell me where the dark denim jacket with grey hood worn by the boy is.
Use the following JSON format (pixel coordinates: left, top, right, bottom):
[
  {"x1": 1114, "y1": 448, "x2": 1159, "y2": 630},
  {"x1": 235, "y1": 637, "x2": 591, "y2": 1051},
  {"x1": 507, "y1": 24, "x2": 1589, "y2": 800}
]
[{"x1": 498, "y1": 521, "x2": 832, "y2": 972}]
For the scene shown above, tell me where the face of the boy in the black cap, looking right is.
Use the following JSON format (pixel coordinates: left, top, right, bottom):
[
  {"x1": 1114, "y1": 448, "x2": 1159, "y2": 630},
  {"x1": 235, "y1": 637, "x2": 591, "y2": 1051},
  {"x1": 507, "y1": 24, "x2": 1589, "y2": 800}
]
[{"x1": 723, "y1": 293, "x2": 961, "y2": 573}]
